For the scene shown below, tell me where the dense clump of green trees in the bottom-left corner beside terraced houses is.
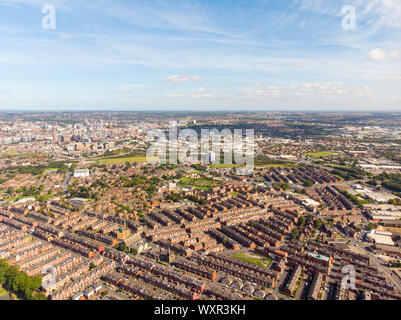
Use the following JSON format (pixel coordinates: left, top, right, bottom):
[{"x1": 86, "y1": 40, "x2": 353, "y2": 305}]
[{"x1": 0, "y1": 259, "x2": 47, "y2": 300}]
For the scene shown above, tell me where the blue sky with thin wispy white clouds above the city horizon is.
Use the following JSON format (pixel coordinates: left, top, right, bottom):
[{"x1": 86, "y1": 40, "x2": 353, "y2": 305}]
[{"x1": 0, "y1": 0, "x2": 401, "y2": 111}]
